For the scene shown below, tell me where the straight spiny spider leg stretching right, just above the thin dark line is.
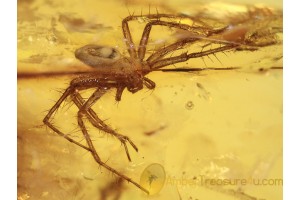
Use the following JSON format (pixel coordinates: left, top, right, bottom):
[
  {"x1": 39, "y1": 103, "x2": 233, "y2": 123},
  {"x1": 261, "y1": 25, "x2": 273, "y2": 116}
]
[{"x1": 149, "y1": 43, "x2": 240, "y2": 69}]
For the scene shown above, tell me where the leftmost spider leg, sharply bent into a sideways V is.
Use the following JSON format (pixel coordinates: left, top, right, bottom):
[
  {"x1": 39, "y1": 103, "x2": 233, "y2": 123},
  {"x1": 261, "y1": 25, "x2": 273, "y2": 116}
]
[{"x1": 43, "y1": 86, "x2": 91, "y2": 151}]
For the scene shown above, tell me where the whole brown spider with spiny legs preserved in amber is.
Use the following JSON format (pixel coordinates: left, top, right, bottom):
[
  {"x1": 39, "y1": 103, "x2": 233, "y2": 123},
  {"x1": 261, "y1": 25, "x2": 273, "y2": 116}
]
[{"x1": 43, "y1": 13, "x2": 282, "y2": 193}]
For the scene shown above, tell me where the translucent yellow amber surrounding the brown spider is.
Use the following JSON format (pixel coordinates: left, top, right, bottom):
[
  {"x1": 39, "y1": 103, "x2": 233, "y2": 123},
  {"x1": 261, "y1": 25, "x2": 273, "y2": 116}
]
[{"x1": 17, "y1": 0, "x2": 282, "y2": 200}]
